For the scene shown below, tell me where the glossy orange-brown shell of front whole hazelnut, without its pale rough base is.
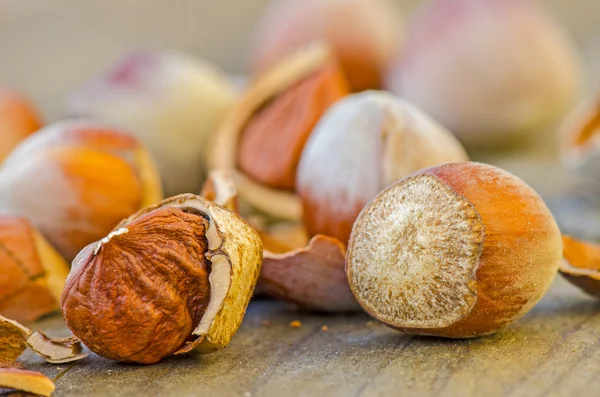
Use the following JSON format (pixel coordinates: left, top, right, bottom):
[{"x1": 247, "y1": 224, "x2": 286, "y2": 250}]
[{"x1": 346, "y1": 163, "x2": 562, "y2": 338}]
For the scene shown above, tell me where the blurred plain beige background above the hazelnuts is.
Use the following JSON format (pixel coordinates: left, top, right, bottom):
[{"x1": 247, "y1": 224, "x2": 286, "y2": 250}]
[{"x1": 0, "y1": 0, "x2": 600, "y2": 121}]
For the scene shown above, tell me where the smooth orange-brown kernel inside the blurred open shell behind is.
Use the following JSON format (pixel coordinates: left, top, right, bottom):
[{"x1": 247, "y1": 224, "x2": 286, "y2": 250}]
[{"x1": 238, "y1": 61, "x2": 349, "y2": 190}]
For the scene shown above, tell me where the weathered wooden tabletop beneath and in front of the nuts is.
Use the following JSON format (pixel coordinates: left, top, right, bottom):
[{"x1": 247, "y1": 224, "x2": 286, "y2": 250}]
[{"x1": 10, "y1": 158, "x2": 600, "y2": 397}]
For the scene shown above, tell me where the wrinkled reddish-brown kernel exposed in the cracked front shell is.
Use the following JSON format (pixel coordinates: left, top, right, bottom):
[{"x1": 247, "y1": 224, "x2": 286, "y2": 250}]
[{"x1": 61, "y1": 208, "x2": 210, "y2": 364}]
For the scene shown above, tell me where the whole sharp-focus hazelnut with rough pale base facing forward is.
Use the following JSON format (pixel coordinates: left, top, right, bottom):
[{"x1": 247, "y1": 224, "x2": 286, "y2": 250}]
[{"x1": 346, "y1": 163, "x2": 562, "y2": 338}]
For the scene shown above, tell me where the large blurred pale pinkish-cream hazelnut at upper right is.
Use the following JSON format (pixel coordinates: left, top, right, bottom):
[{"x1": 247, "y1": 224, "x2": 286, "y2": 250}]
[{"x1": 387, "y1": 0, "x2": 581, "y2": 147}]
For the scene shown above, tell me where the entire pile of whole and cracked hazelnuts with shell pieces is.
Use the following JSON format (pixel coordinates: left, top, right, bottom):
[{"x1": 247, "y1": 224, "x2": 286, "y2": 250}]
[{"x1": 0, "y1": 0, "x2": 600, "y2": 395}]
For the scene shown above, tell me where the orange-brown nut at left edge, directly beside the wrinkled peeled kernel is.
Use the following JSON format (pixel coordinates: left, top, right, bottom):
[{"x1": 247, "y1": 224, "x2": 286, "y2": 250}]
[{"x1": 0, "y1": 214, "x2": 69, "y2": 322}]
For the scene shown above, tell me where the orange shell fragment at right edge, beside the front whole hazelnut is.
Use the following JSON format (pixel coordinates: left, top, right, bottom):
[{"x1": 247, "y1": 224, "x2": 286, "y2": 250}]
[{"x1": 558, "y1": 236, "x2": 600, "y2": 298}]
